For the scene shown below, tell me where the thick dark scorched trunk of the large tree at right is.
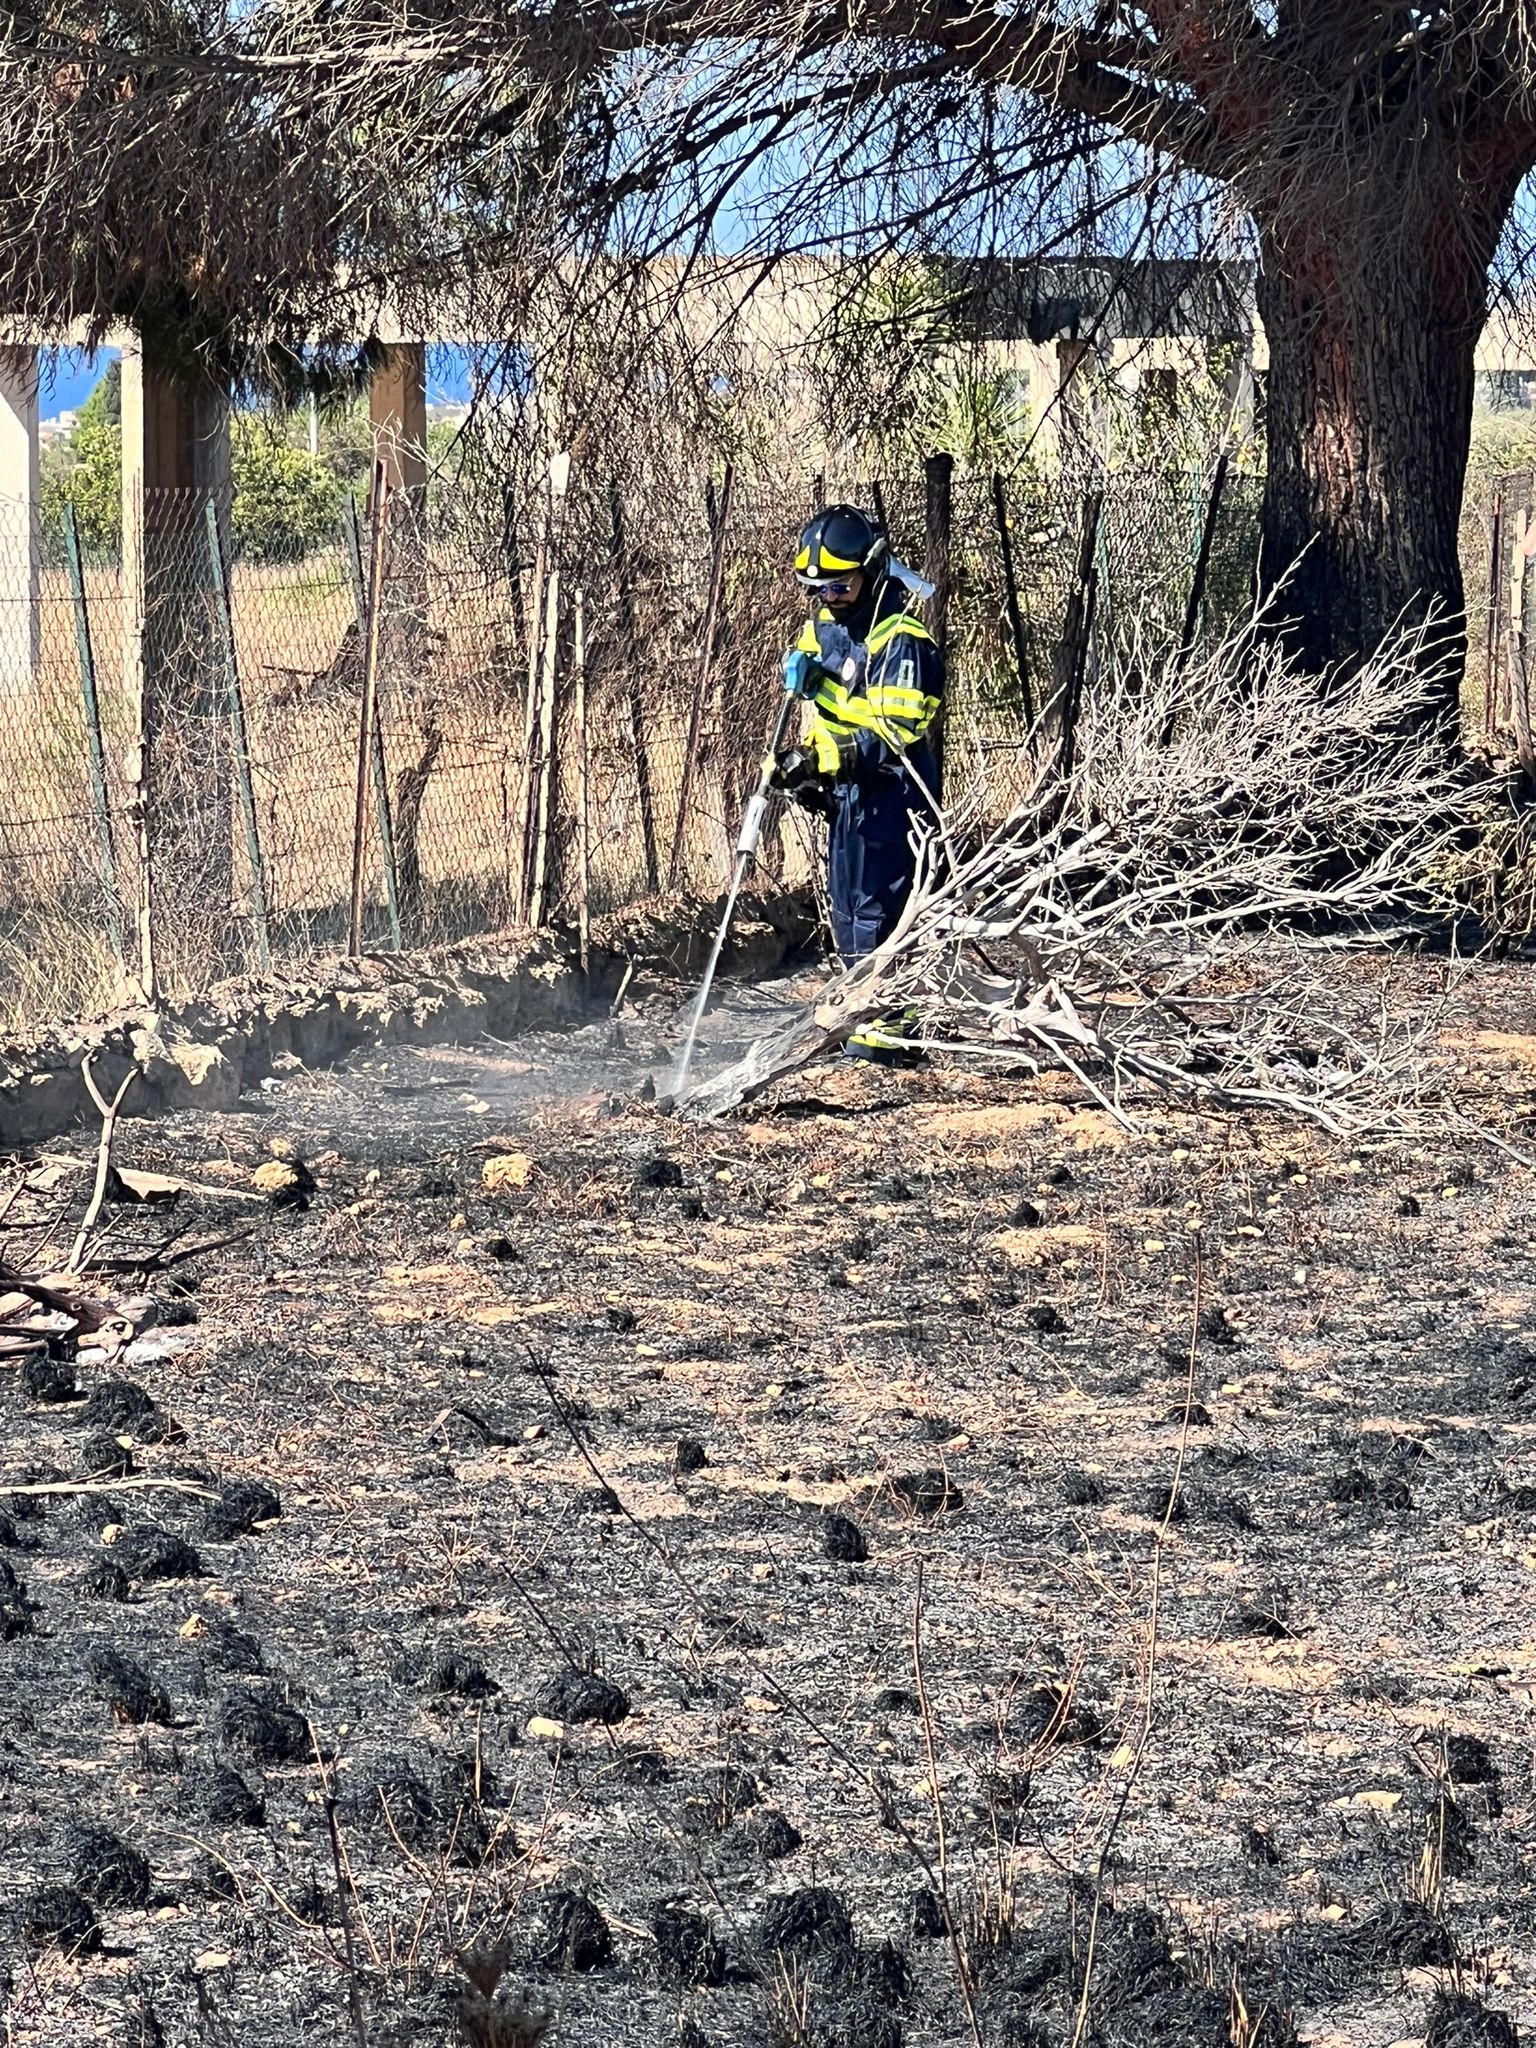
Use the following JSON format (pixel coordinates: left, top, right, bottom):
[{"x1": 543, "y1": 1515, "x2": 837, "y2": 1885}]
[{"x1": 1257, "y1": 130, "x2": 1524, "y2": 729}]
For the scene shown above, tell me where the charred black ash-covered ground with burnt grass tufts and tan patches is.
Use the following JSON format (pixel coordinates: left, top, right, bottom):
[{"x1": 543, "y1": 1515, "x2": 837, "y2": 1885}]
[{"x1": 0, "y1": 961, "x2": 1536, "y2": 2048}]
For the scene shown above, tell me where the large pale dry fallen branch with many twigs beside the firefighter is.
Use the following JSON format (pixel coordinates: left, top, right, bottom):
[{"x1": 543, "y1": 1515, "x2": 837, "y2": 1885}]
[{"x1": 676, "y1": 618, "x2": 1470, "y2": 1135}]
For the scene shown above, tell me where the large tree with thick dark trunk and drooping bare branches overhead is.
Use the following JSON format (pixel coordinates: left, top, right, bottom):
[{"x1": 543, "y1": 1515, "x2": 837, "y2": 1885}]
[{"x1": 12, "y1": 0, "x2": 1536, "y2": 704}]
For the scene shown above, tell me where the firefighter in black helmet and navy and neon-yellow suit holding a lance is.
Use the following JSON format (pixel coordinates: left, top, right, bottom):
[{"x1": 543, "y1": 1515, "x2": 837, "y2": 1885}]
[{"x1": 774, "y1": 504, "x2": 944, "y2": 1065}]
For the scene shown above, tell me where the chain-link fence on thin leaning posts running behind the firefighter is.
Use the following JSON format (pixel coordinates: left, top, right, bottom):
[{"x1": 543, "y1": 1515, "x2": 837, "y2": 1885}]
[{"x1": 0, "y1": 463, "x2": 1255, "y2": 1028}]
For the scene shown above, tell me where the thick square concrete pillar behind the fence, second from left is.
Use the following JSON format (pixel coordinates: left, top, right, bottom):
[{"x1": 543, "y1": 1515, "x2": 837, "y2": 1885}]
[{"x1": 123, "y1": 340, "x2": 233, "y2": 995}]
